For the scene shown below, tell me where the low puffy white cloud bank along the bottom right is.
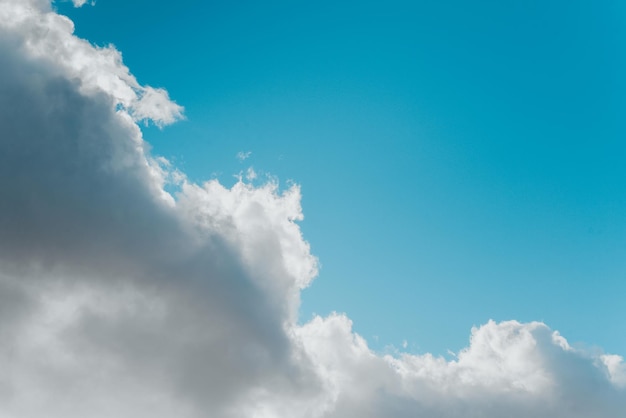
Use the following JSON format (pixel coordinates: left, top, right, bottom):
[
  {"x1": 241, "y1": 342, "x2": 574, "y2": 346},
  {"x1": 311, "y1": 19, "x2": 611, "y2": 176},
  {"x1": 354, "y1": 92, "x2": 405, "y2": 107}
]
[{"x1": 292, "y1": 314, "x2": 626, "y2": 418}]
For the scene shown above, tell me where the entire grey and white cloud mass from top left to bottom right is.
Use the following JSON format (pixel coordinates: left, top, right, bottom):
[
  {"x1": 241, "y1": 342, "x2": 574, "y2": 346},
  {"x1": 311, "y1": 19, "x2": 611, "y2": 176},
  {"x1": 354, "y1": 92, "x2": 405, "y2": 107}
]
[{"x1": 0, "y1": 0, "x2": 626, "y2": 418}]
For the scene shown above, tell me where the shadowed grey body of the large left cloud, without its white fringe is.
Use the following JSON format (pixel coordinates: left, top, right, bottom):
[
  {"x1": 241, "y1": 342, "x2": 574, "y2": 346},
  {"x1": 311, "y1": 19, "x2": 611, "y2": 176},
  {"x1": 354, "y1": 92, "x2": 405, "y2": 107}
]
[{"x1": 0, "y1": 22, "x2": 314, "y2": 416}]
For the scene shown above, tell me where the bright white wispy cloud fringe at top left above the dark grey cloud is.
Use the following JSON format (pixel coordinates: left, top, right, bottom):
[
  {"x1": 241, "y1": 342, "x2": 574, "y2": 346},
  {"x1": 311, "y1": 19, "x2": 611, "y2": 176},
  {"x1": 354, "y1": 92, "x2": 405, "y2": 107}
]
[{"x1": 0, "y1": 0, "x2": 183, "y2": 126}]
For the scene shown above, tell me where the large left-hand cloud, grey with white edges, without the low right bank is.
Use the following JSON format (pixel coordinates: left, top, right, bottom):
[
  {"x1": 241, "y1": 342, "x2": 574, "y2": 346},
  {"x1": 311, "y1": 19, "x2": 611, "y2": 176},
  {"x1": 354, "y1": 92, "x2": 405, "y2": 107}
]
[{"x1": 0, "y1": 1, "x2": 316, "y2": 417}]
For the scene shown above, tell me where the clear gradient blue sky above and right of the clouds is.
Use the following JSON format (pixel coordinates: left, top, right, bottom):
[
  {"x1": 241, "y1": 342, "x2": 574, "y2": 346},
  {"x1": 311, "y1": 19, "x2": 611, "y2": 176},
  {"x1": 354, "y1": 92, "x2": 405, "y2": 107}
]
[{"x1": 57, "y1": 0, "x2": 626, "y2": 354}]
